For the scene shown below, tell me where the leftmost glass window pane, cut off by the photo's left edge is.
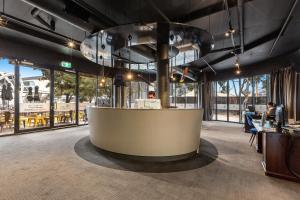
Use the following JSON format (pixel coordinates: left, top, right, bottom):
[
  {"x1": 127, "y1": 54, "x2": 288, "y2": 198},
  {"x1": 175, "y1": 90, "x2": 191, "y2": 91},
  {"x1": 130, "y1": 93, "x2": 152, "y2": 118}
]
[{"x1": 0, "y1": 59, "x2": 15, "y2": 135}]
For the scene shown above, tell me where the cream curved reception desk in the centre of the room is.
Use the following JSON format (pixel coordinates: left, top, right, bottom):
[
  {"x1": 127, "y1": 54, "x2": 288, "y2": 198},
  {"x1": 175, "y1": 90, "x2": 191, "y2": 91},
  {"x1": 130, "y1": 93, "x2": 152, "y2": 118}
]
[{"x1": 88, "y1": 107, "x2": 203, "y2": 160}]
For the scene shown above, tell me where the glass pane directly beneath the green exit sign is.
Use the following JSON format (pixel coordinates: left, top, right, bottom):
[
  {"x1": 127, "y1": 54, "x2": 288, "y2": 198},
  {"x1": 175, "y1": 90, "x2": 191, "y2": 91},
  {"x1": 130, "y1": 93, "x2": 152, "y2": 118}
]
[{"x1": 54, "y1": 71, "x2": 76, "y2": 126}]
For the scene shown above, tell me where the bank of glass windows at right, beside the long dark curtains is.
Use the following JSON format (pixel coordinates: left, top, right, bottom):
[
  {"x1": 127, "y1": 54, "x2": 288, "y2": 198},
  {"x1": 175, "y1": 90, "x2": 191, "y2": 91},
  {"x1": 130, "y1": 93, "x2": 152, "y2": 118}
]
[{"x1": 212, "y1": 74, "x2": 270, "y2": 123}]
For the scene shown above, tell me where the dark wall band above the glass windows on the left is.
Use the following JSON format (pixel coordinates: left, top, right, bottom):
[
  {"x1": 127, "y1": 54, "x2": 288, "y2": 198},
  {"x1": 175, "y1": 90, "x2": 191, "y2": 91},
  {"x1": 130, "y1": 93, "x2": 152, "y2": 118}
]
[{"x1": 0, "y1": 34, "x2": 159, "y2": 81}]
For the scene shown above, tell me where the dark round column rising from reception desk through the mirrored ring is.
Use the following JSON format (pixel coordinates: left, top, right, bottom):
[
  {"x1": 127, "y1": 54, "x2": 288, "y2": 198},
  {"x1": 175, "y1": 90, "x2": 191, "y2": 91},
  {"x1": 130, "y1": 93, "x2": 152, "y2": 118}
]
[{"x1": 156, "y1": 23, "x2": 170, "y2": 108}]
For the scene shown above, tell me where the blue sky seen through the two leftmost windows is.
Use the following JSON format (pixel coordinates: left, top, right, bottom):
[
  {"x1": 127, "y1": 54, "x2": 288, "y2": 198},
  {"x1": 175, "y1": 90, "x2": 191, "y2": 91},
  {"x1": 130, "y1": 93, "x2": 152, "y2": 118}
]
[{"x1": 0, "y1": 59, "x2": 42, "y2": 77}]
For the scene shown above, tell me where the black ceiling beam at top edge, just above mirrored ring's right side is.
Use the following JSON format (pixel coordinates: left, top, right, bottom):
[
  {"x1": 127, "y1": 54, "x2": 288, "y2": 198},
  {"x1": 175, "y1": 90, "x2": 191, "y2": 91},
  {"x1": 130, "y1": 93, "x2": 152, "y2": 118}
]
[{"x1": 173, "y1": 0, "x2": 253, "y2": 23}]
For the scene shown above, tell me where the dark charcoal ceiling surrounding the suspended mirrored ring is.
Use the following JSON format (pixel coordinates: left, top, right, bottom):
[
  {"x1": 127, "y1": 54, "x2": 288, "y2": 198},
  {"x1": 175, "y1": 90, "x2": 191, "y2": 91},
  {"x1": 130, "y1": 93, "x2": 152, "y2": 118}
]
[{"x1": 0, "y1": 0, "x2": 300, "y2": 76}]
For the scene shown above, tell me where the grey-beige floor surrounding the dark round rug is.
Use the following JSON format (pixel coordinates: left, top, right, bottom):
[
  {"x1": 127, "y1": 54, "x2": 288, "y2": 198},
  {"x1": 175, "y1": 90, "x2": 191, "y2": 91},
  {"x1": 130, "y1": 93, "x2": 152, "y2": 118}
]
[{"x1": 0, "y1": 122, "x2": 300, "y2": 200}]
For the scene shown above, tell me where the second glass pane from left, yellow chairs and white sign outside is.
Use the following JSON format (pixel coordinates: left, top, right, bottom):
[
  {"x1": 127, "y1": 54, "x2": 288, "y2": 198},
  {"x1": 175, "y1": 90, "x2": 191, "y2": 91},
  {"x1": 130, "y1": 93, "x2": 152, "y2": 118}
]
[{"x1": 19, "y1": 66, "x2": 50, "y2": 130}]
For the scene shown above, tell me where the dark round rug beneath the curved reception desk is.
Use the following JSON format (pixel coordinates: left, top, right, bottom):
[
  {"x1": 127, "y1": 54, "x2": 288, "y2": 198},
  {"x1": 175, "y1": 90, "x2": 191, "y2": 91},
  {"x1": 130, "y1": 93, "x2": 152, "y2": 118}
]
[{"x1": 74, "y1": 136, "x2": 218, "y2": 173}]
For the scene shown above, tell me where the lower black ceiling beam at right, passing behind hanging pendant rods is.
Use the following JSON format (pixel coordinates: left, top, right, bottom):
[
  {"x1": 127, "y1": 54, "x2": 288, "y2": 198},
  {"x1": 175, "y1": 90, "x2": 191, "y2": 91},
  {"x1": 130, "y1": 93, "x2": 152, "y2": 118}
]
[{"x1": 209, "y1": 29, "x2": 280, "y2": 65}]
